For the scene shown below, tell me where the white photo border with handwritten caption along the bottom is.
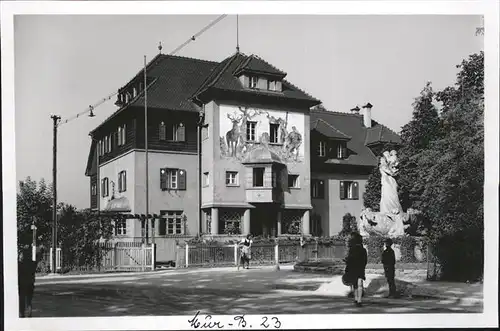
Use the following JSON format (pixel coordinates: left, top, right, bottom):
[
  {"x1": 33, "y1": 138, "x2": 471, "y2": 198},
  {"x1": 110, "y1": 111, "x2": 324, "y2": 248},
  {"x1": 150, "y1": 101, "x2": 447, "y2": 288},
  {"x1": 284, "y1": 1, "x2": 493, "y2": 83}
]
[{"x1": 0, "y1": 1, "x2": 499, "y2": 330}]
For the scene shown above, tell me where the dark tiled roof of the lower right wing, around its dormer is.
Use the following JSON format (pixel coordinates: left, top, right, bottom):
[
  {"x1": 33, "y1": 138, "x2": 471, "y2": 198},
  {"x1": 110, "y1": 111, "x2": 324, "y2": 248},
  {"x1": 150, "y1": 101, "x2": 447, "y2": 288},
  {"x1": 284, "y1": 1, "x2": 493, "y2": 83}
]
[{"x1": 311, "y1": 110, "x2": 401, "y2": 166}]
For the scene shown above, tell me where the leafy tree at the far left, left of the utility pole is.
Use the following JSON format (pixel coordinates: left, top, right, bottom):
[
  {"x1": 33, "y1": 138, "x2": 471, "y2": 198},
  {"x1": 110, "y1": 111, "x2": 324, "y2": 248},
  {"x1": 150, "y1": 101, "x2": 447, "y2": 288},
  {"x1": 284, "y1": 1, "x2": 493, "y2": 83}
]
[{"x1": 17, "y1": 177, "x2": 52, "y2": 252}]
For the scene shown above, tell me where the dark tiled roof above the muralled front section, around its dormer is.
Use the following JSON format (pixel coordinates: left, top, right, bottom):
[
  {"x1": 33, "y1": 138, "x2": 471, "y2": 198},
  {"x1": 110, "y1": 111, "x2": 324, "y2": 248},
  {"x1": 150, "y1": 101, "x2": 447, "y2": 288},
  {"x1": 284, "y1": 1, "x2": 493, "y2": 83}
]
[{"x1": 194, "y1": 53, "x2": 320, "y2": 104}]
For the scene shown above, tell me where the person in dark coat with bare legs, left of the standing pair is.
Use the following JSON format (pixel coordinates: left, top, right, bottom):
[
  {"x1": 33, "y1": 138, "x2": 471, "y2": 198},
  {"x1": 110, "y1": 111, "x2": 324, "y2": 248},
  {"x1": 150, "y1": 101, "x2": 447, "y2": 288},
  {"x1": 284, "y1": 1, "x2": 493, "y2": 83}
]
[{"x1": 344, "y1": 232, "x2": 368, "y2": 307}]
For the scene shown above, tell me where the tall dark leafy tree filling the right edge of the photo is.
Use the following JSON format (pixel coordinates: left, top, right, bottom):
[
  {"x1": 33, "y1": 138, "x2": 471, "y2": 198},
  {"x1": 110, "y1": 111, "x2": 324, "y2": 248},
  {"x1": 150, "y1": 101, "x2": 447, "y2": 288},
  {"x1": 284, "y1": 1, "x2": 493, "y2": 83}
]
[{"x1": 417, "y1": 52, "x2": 484, "y2": 280}]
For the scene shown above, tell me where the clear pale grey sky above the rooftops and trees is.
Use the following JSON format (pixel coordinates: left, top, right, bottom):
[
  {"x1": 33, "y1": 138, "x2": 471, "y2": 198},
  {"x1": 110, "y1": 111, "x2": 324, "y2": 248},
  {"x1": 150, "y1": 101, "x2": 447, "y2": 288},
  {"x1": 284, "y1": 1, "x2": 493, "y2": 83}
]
[{"x1": 14, "y1": 15, "x2": 483, "y2": 208}]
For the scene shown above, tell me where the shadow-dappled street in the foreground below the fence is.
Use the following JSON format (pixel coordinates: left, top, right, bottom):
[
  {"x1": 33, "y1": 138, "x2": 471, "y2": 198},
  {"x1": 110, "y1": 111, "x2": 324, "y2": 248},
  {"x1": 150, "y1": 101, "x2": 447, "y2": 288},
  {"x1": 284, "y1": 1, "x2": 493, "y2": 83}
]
[{"x1": 29, "y1": 268, "x2": 482, "y2": 317}]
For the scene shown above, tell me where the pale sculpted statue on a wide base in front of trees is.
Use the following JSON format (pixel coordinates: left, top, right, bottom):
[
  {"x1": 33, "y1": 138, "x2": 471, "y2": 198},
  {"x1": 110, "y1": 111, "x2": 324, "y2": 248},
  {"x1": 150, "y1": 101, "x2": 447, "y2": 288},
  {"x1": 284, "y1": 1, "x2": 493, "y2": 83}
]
[{"x1": 358, "y1": 150, "x2": 410, "y2": 238}]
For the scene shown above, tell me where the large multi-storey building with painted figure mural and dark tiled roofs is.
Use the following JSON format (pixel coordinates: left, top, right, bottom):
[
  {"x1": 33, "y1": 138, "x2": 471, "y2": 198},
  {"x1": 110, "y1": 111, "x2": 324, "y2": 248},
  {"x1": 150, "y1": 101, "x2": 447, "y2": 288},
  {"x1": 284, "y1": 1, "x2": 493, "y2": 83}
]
[{"x1": 86, "y1": 52, "x2": 399, "y2": 259}]
